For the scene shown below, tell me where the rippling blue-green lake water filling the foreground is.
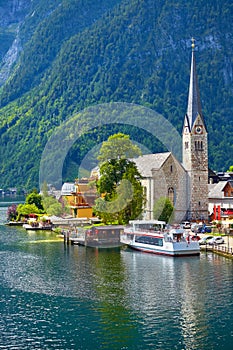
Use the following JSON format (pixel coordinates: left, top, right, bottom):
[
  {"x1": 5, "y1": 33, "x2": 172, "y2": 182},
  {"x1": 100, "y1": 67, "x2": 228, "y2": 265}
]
[{"x1": 0, "y1": 207, "x2": 233, "y2": 350}]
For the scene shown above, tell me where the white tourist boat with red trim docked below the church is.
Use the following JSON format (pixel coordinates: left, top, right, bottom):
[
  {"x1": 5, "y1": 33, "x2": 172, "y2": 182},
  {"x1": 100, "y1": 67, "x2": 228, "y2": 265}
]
[{"x1": 121, "y1": 220, "x2": 200, "y2": 256}]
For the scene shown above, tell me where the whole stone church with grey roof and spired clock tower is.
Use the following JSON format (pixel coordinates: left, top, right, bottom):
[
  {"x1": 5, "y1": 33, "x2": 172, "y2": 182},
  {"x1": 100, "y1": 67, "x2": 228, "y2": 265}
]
[{"x1": 134, "y1": 39, "x2": 208, "y2": 222}]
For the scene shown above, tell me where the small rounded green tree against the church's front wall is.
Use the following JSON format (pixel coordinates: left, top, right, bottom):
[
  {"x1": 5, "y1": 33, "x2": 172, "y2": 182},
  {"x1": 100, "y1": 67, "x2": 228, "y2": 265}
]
[{"x1": 153, "y1": 197, "x2": 174, "y2": 223}]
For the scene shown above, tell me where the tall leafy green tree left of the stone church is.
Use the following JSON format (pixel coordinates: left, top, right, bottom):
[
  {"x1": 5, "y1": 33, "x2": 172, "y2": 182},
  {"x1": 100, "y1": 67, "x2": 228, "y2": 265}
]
[{"x1": 94, "y1": 133, "x2": 145, "y2": 223}]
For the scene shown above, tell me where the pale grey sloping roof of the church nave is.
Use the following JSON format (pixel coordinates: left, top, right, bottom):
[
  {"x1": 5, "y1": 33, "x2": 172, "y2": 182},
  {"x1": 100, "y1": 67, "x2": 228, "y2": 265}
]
[{"x1": 133, "y1": 152, "x2": 171, "y2": 177}]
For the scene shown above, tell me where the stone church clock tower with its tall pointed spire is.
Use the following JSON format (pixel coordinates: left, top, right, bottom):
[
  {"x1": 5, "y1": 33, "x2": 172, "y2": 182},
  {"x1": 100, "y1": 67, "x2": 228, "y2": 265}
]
[{"x1": 182, "y1": 39, "x2": 208, "y2": 220}]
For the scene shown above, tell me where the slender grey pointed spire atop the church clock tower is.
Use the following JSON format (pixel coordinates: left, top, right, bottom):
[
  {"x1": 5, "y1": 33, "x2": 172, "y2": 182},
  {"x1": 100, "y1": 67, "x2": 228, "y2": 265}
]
[{"x1": 186, "y1": 38, "x2": 204, "y2": 131}]
